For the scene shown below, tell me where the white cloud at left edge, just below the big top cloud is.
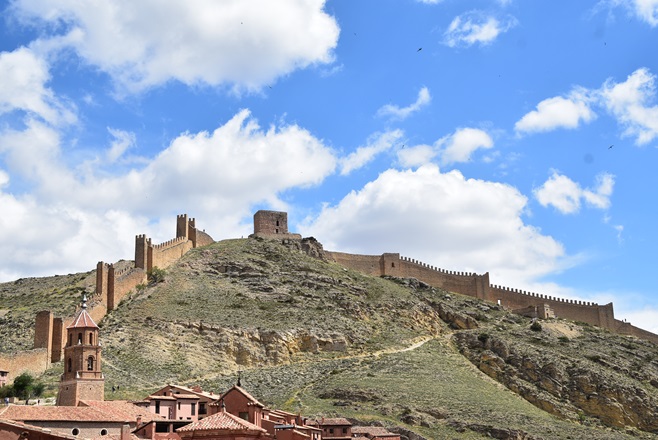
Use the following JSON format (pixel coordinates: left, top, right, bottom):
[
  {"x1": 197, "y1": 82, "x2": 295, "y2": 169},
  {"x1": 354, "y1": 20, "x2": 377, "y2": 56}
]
[{"x1": 0, "y1": 47, "x2": 75, "y2": 124}]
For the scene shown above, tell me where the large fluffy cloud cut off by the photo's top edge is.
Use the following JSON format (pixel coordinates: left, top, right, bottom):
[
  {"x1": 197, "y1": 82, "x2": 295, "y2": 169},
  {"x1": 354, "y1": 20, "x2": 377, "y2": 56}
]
[{"x1": 13, "y1": 0, "x2": 339, "y2": 91}]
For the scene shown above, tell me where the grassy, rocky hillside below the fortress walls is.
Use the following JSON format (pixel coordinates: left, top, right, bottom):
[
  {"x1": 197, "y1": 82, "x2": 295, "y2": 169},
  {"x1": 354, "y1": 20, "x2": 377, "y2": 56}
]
[{"x1": 0, "y1": 239, "x2": 658, "y2": 439}]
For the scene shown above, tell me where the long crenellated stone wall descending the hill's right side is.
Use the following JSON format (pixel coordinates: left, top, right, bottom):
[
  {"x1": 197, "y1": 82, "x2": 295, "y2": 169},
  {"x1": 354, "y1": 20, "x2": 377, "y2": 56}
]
[{"x1": 325, "y1": 251, "x2": 658, "y2": 344}]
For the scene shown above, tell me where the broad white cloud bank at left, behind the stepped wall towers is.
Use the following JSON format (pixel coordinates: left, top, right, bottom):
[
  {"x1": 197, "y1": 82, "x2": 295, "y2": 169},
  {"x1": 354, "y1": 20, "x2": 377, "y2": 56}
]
[{"x1": 0, "y1": 110, "x2": 336, "y2": 279}]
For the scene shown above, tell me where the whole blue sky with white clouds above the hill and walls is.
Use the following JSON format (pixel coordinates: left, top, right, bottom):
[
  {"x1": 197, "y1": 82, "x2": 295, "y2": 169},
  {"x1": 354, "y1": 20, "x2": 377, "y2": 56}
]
[{"x1": 0, "y1": 0, "x2": 658, "y2": 333}]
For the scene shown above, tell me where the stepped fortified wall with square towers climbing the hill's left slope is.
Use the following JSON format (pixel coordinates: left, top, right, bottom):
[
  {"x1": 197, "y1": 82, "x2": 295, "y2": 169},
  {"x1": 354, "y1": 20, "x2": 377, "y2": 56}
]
[{"x1": 27, "y1": 214, "x2": 214, "y2": 376}]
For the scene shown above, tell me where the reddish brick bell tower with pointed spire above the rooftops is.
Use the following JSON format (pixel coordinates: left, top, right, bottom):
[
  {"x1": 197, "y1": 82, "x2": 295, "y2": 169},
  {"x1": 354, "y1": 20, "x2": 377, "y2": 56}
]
[{"x1": 57, "y1": 296, "x2": 105, "y2": 406}]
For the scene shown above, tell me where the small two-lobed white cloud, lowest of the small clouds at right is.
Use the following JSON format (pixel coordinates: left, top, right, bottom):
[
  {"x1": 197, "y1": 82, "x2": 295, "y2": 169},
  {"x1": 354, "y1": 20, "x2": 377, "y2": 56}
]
[{"x1": 534, "y1": 171, "x2": 615, "y2": 214}]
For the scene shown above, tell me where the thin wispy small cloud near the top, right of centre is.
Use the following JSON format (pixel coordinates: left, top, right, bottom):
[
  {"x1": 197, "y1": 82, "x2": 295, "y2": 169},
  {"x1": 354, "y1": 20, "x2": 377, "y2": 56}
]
[{"x1": 443, "y1": 11, "x2": 517, "y2": 47}]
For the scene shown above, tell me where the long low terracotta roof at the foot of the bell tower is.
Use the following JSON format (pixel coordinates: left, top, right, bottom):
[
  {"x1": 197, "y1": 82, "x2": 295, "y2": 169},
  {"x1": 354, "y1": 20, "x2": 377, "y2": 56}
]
[{"x1": 2, "y1": 405, "x2": 135, "y2": 423}]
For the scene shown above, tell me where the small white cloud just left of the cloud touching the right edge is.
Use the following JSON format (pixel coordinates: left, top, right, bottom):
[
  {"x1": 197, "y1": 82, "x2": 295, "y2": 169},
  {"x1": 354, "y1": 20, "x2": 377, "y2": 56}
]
[{"x1": 514, "y1": 89, "x2": 596, "y2": 133}]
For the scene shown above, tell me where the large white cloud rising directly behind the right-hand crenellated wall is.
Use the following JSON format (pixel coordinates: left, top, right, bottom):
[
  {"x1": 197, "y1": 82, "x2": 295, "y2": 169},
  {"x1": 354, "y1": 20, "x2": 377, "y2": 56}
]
[{"x1": 301, "y1": 165, "x2": 565, "y2": 286}]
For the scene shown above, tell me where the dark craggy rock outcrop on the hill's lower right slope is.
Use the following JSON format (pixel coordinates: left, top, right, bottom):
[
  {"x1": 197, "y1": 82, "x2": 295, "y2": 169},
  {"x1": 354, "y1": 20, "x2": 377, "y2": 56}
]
[{"x1": 454, "y1": 332, "x2": 658, "y2": 431}]
